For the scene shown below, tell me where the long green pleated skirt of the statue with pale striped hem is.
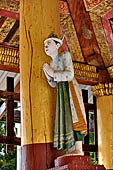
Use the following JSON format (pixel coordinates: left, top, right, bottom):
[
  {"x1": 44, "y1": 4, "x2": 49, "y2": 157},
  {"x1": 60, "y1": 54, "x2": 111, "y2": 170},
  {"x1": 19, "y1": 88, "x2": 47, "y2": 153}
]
[{"x1": 54, "y1": 82, "x2": 75, "y2": 151}]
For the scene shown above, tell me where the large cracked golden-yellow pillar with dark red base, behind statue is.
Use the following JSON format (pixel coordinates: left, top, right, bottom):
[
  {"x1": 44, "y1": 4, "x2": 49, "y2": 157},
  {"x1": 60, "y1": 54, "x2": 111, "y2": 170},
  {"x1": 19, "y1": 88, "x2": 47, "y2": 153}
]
[{"x1": 20, "y1": 0, "x2": 63, "y2": 170}]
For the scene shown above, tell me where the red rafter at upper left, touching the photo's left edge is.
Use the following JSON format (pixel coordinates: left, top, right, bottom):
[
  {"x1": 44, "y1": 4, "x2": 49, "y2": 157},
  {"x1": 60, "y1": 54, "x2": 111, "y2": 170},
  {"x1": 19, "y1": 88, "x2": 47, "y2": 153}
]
[{"x1": 0, "y1": 9, "x2": 20, "y2": 20}]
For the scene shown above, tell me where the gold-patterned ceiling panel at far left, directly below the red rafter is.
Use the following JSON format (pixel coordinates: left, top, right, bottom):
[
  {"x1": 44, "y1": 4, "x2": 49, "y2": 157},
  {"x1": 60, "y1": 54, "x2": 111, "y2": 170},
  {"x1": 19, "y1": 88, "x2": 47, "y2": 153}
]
[{"x1": 0, "y1": 18, "x2": 16, "y2": 43}]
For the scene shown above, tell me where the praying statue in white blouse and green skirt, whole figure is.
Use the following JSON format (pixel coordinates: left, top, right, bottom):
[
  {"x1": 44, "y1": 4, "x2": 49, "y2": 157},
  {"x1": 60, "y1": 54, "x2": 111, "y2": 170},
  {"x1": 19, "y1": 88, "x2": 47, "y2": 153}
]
[{"x1": 43, "y1": 34, "x2": 87, "y2": 155}]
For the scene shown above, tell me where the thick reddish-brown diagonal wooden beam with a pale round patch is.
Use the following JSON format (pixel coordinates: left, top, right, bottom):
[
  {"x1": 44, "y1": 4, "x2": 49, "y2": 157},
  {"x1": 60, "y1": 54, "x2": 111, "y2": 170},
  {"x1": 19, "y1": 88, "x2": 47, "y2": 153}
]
[{"x1": 68, "y1": 0, "x2": 104, "y2": 68}]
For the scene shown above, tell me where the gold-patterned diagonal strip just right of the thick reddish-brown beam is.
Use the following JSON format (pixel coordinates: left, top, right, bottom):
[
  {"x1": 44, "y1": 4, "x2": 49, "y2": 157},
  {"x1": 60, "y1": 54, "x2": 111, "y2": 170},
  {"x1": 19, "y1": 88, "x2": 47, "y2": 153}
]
[{"x1": 89, "y1": 12, "x2": 113, "y2": 67}]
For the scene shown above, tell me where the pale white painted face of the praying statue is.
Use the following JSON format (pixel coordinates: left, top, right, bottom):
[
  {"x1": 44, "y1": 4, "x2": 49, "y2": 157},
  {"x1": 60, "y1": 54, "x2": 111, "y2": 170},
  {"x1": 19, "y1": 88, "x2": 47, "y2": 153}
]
[{"x1": 44, "y1": 40, "x2": 58, "y2": 56}]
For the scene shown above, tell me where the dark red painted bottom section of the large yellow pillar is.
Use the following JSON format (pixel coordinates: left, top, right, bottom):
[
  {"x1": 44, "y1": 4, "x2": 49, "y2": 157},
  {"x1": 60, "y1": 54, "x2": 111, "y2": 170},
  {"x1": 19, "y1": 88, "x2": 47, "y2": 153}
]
[{"x1": 21, "y1": 143, "x2": 63, "y2": 170}]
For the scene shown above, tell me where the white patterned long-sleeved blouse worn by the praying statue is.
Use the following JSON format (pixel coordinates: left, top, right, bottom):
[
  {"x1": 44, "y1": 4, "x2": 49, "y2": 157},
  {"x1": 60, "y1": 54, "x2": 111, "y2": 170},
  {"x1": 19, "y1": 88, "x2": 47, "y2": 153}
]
[{"x1": 48, "y1": 51, "x2": 74, "y2": 87}]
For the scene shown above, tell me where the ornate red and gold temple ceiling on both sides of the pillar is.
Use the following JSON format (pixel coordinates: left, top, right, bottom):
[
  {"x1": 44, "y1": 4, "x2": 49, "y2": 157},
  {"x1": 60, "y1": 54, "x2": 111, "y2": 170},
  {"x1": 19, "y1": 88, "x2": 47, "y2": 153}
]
[{"x1": 0, "y1": 0, "x2": 113, "y2": 85}]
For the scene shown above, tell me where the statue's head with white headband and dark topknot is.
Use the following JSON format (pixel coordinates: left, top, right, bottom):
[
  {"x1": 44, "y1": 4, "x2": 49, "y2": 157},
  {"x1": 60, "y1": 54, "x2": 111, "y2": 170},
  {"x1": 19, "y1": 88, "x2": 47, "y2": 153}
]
[{"x1": 44, "y1": 33, "x2": 62, "y2": 56}]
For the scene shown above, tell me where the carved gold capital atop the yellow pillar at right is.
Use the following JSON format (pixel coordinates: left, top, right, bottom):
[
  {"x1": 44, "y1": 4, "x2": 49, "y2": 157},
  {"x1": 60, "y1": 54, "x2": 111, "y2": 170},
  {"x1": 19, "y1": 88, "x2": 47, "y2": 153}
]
[{"x1": 92, "y1": 83, "x2": 113, "y2": 97}]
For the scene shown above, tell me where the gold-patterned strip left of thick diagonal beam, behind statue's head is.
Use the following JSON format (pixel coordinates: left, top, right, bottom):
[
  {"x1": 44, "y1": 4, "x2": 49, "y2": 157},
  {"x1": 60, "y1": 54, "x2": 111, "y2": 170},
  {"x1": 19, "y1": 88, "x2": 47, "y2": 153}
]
[{"x1": 60, "y1": 14, "x2": 84, "y2": 62}]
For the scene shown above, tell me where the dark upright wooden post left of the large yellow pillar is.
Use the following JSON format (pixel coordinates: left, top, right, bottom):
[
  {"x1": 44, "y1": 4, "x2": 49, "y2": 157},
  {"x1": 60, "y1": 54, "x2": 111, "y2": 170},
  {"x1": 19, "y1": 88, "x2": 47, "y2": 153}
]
[{"x1": 6, "y1": 77, "x2": 14, "y2": 152}]
